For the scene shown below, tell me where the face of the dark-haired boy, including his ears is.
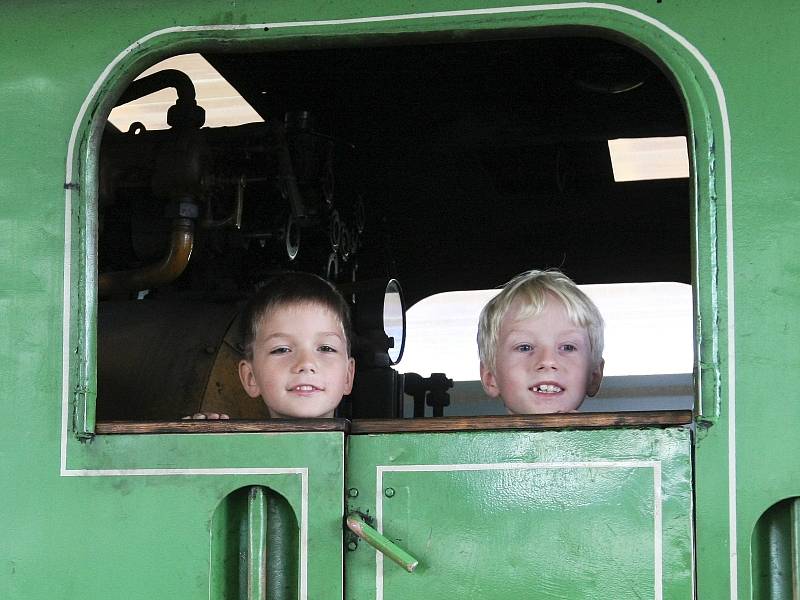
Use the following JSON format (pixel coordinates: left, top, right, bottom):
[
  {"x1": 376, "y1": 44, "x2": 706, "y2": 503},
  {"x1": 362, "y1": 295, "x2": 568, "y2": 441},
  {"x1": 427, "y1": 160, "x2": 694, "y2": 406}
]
[{"x1": 239, "y1": 304, "x2": 355, "y2": 419}]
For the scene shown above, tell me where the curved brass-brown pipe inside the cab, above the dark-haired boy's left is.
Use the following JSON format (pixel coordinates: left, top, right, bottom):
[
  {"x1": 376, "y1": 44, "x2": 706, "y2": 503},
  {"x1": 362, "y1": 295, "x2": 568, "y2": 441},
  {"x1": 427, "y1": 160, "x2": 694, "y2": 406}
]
[{"x1": 97, "y1": 218, "x2": 194, "y2": 297}]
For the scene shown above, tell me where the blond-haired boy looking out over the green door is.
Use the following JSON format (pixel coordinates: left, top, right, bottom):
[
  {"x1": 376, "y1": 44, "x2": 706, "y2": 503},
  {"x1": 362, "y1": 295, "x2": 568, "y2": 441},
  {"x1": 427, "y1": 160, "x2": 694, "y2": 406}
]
[{"x1": 478, "y1": 270, "x2": 604, "y2": 414}]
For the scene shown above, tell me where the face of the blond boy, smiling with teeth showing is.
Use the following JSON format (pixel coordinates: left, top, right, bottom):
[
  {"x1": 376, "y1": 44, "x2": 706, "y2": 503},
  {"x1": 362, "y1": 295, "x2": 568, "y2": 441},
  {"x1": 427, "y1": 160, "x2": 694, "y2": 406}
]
[{"x1": 481, "y1": 295, "x2": 603, "y2": 414}]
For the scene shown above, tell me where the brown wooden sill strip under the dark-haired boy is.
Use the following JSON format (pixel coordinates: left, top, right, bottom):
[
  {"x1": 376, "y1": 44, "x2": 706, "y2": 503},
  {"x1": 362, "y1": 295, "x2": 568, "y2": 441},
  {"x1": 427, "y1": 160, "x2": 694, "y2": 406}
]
[{"x1": 95, "y1": 419, "x2": 350, "y2": 435}]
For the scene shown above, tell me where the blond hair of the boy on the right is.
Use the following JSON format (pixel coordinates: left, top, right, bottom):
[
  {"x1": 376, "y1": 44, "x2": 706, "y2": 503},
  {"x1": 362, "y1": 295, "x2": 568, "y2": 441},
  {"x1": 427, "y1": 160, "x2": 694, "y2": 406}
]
[{"x1": 478, "y1": 270, "x2": 603, "y2": 371}]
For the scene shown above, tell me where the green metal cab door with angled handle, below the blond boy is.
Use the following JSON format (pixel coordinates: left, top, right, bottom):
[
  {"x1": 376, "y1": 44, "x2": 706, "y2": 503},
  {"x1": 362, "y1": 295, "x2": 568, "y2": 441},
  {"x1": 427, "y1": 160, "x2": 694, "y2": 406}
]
[{"x1": 345, "y1": 427, "x2": 693, "y2": 600}]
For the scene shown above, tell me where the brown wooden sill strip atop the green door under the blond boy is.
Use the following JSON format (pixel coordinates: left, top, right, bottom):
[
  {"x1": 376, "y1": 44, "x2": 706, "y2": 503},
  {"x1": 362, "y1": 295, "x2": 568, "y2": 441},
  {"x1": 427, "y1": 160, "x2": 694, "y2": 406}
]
[{"x1": 350, "y1": 410, "x2": 692, "y2": 434}]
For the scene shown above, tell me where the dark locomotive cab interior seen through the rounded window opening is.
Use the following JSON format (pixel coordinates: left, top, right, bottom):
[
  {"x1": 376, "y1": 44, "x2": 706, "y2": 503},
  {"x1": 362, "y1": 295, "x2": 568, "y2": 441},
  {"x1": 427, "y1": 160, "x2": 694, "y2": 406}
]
[{"x1": 97, "y1": 36, "x2": 691, "y2": 421}]
